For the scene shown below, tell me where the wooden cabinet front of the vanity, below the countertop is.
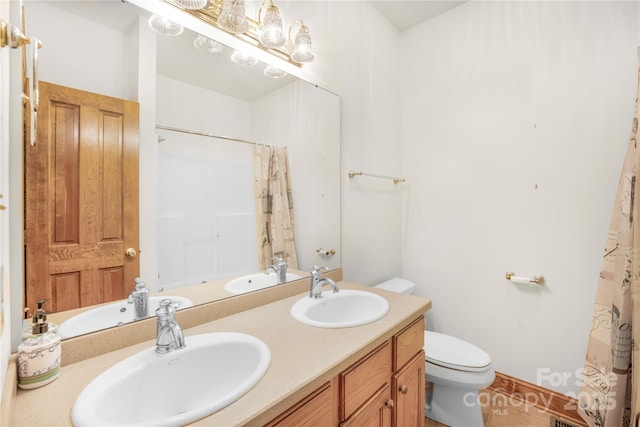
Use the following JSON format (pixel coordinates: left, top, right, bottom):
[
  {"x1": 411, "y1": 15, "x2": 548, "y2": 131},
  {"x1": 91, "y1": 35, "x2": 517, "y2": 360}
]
[{"x1": 267, "y1": 316, "x2": 425, "y2": 427}]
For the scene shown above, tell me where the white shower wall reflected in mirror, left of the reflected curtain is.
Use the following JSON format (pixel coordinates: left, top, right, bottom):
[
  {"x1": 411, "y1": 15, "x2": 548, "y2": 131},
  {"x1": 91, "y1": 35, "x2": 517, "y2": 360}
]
[{"x1": 156, "y1": 76, "x2": 258, "y2": 289}]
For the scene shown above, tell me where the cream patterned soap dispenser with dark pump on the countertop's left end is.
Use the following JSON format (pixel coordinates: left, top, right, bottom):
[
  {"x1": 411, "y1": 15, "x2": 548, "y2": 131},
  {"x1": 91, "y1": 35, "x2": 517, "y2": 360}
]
[{"x1": 18, "y1": 300, "x2": 62, "y2": 389}]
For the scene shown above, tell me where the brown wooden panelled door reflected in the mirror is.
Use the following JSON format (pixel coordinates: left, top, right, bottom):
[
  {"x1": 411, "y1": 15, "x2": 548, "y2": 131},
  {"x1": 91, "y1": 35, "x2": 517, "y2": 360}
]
[{"x1": 25, "y1": 82, "x2": 140, "y2": 312}]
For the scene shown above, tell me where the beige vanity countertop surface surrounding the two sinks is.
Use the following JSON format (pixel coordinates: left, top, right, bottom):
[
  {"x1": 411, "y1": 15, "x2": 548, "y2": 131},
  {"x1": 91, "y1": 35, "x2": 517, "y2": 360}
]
[{"x1": 11, "y1": 281, "x2": 431, "y2": 427}]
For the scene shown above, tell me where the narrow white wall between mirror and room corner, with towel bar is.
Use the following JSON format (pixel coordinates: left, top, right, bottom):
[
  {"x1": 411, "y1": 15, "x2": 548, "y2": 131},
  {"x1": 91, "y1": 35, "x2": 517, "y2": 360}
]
[{"x1": 278, "y1": 1, "x2": 402, "y2": 284}]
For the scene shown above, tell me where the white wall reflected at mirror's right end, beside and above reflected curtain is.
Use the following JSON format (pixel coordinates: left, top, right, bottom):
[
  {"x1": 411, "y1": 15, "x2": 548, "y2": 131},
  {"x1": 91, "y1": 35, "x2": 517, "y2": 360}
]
[{"x1": 251, "y1": 80, "x2": 342, "y2": 272}]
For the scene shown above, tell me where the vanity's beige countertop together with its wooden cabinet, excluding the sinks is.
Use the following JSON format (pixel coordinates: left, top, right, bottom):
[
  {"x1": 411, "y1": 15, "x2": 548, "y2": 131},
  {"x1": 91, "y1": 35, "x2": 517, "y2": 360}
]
[{"x1": 0, "y1": 280, "x2": 431, "y2": 426}]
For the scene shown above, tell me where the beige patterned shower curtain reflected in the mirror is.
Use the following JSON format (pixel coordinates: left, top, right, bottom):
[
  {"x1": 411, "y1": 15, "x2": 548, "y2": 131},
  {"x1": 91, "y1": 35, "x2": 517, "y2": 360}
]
[{"x1": 253, "y1": 146, "x2": 298, "y2": 269}]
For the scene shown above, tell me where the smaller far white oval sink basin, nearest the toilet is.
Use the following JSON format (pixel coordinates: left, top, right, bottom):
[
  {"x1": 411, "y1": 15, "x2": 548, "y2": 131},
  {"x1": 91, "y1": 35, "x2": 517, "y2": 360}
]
[{"x1": 291, "y1": 289, "x2": 389, "y2": 328}]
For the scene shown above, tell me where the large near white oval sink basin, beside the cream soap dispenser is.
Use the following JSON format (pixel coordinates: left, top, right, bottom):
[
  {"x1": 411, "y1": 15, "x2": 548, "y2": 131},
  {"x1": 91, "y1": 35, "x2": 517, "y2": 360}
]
[{"x1": 71, "y1": 332, "x2": 271, "y2": 427}]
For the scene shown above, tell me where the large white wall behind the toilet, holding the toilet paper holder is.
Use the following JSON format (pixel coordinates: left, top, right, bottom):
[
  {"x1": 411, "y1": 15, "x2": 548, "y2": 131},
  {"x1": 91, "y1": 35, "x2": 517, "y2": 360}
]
[{"x1": 401, "y1": 1, "x2": 640, "y2": 392}]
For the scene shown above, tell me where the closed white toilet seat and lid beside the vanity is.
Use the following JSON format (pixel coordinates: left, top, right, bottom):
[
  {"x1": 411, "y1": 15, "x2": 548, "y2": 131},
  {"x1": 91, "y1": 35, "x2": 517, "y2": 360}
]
[{"x1": 424, "y1": 331, "x2": 491, "y2": 372}]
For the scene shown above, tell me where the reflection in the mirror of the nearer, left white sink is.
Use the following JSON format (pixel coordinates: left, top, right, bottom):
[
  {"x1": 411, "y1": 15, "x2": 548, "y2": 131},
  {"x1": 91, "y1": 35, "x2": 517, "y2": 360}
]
[{"x1": 58, "y1": 296, "x2": 193, "y2": 338}]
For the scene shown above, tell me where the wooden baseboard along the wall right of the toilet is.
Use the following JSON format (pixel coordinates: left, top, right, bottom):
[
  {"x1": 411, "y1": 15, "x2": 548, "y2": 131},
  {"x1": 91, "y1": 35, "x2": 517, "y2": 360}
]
[{"x1": 488, "y1": 372, "x2": 587, "y2": 427}]
